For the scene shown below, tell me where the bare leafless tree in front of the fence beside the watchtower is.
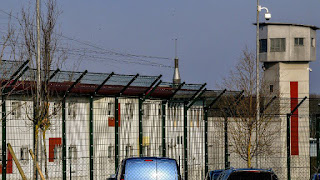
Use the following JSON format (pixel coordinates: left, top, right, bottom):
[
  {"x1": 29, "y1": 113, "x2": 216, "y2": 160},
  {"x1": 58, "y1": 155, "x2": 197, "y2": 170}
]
[{"x1": 220, "y1": 48, "x2": 280, "y2": 167}]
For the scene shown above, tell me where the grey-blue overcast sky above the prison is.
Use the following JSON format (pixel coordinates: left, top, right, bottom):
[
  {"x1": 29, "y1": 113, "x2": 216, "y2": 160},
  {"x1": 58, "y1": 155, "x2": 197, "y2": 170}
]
[{"x1": 0, "y1": 0, "x2": 320, "y2": 94}]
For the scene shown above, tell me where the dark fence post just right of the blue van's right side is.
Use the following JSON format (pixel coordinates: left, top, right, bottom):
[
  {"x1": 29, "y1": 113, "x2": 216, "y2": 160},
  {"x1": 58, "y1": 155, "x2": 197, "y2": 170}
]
[{"x1": 183, "y1": 103, "x2": 188, "y2": 180}]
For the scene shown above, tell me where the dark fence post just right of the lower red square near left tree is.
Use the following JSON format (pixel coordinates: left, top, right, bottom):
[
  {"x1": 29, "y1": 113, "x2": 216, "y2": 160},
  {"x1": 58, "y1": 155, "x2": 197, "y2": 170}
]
[{"x1": 62, "y1": 98, "x2": 67, "y2": 180}]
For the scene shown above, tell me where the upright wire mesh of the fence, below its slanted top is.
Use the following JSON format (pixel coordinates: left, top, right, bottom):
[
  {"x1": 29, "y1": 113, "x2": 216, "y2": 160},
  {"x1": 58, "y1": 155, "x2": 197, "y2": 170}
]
[{"x1": 0, "y1": 93, "x2": 320, "y2": 180}]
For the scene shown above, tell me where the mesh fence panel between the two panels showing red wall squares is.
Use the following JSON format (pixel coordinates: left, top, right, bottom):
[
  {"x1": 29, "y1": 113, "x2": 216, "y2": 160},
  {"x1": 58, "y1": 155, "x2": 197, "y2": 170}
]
[{"x1": 66, "y1": 98, "x2": 90, "y2": 179}]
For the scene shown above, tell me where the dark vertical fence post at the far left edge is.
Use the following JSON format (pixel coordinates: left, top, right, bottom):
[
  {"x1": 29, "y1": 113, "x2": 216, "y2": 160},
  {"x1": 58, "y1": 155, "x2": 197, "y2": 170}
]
[{"x1": 2, "y1": 92, "x2": 7, "y2": 180}]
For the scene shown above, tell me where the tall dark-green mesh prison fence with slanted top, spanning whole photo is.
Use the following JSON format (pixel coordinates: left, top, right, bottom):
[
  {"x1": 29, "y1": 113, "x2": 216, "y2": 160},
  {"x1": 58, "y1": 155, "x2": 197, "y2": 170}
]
[{"x1": 0, "y1": 60, "x2": 320, "y2": 180}]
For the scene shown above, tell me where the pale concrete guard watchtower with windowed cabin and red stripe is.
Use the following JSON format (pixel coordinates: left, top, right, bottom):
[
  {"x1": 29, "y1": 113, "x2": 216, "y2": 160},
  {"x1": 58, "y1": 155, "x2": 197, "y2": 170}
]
[{"x1": 259, "y1": 23, "x2": 319, "y2": 179}]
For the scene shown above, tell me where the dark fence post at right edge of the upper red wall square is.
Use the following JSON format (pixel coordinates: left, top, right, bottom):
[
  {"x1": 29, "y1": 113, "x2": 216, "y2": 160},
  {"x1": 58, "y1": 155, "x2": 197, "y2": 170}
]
[{"x1": 114, "y1": 97, "x2": 119, "y2": 171}]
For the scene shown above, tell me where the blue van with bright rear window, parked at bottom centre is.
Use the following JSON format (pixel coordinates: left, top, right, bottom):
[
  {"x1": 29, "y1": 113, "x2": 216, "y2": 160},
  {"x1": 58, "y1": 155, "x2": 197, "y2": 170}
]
[{"x1": 110, "y1": 157, "x2": 181, "y2": 180}]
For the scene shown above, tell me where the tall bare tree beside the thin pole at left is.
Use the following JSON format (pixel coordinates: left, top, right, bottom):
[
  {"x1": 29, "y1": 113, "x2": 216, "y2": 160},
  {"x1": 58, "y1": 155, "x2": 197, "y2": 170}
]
[{"x1": 19, "y1": 0, "x2": 66, "y2": 179}]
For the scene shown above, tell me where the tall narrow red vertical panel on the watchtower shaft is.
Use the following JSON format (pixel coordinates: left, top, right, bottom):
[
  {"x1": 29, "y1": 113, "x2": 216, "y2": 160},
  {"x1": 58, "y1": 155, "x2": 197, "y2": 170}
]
[{"x1": 290, "y1": 82, "x2": 299, "y2": 155}]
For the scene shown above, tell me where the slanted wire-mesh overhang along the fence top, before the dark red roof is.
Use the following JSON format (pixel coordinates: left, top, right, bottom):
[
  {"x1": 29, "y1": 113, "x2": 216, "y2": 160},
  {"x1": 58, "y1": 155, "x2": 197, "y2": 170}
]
[{"x1": 0, "y1": 60, "x2": 239, "y2": 100}]
